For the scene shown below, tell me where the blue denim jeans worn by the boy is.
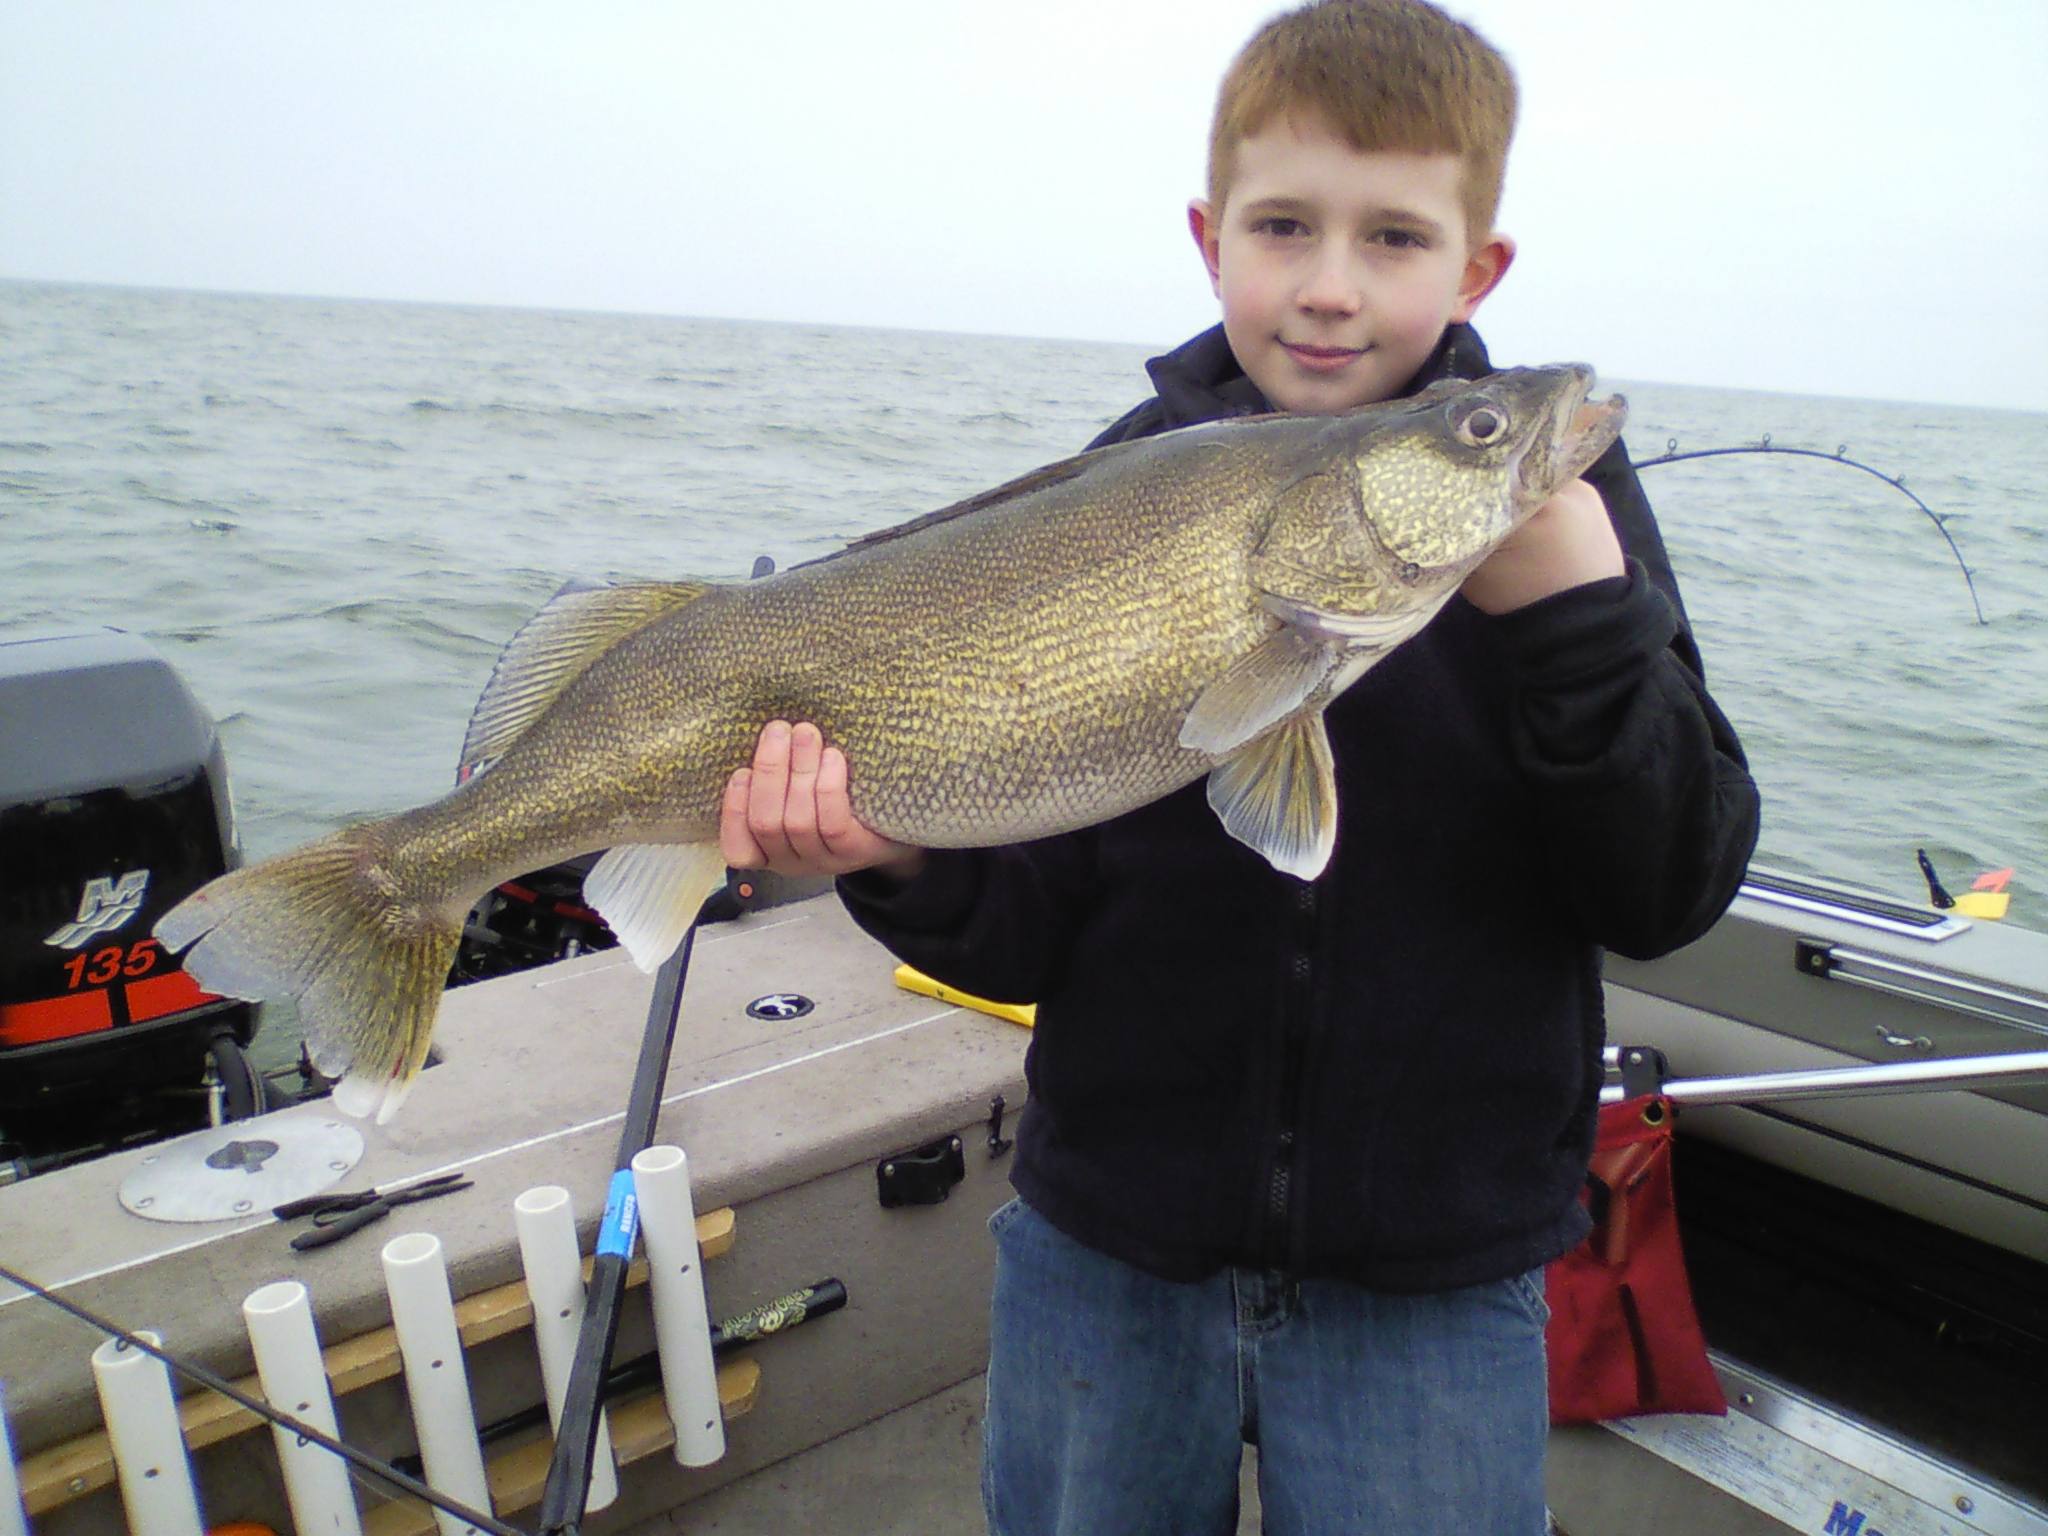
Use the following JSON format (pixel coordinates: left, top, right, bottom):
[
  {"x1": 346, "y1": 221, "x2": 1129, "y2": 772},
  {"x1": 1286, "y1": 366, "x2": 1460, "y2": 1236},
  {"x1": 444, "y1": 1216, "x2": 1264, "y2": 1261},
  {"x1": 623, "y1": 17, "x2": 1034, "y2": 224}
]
[{"x1": 981, "y1": 1200, "x2": 1548, "y2": 1536}]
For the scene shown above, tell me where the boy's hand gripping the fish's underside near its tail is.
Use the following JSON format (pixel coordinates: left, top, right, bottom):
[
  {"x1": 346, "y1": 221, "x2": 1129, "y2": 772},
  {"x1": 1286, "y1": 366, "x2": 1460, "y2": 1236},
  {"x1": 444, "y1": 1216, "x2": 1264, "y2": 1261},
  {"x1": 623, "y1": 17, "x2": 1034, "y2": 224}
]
[{"x1": 719, "y1": 721, "x2": 924, "y2": 881}]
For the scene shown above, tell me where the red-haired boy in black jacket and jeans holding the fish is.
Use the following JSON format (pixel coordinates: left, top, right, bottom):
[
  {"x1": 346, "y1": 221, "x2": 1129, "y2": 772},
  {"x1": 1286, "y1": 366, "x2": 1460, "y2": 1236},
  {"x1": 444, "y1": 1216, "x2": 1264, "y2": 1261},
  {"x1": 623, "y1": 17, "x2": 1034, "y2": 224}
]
[{"x1": 723, "y1": 0, "x2": 1757, "y2": 1536}]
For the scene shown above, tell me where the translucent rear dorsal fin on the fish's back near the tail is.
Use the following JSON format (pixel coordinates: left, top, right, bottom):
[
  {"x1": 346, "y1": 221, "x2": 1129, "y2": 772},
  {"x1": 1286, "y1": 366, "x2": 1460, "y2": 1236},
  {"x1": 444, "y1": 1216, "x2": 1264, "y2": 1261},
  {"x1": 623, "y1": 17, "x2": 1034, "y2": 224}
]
[{"x1": 457, "y1": 582, "x2": 711, "y2": 780}]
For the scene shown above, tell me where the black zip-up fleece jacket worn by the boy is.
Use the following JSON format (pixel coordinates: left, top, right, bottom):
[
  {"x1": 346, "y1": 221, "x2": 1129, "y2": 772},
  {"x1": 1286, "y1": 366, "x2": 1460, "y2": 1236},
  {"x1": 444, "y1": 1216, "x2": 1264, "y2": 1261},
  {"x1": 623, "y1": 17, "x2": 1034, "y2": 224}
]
[{"x1": 840, "y1": 326, "x2": 1757, "y2": 1290}]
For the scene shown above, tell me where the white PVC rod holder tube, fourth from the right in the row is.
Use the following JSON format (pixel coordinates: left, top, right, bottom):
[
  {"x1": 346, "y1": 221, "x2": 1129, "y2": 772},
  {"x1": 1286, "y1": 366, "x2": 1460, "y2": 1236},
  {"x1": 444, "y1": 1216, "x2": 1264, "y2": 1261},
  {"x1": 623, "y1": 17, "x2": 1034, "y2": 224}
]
[{"x1": 242, "y1": 1280, "x2": 362, "y2": 1536}]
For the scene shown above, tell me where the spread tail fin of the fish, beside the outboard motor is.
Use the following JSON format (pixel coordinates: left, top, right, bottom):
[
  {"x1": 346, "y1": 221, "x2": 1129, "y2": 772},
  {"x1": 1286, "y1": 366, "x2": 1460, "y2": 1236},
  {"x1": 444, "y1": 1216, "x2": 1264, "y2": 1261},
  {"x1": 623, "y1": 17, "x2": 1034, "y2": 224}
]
[{"x1": 156, "y1": 821, "x2": 463, "y2": 1124}]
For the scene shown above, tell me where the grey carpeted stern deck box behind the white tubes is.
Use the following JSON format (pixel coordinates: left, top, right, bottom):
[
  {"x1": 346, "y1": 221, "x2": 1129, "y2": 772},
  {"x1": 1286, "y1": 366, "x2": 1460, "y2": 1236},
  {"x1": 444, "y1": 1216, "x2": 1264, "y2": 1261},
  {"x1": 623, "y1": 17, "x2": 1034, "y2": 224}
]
[{"x1": 0, "y1": 897, "x2": 1028, "y2": 1536}]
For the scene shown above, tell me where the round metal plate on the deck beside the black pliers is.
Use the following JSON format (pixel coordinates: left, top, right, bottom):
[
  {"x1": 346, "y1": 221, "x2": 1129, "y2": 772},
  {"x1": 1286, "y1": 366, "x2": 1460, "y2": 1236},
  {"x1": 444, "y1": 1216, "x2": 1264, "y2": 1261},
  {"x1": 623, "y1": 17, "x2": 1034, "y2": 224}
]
[{"x1": 121, "y1": 1114, "x2": 362, "y2": 1221}]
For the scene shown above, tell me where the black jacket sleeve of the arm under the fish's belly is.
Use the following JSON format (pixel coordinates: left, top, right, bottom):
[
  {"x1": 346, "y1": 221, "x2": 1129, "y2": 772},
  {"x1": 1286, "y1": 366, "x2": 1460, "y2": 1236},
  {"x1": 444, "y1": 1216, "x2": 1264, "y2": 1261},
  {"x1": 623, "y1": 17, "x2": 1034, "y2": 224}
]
[{"x1": 840, "y1": 827, "x2": 1096, "y2": 1004}]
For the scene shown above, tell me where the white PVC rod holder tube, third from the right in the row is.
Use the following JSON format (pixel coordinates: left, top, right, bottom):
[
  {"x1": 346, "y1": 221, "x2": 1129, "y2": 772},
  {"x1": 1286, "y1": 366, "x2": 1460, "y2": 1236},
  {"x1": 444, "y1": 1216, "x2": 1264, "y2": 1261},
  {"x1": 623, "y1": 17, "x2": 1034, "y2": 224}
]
[{"x1": 383, "y1": 1233, "x2": 492, "y2": 1536}]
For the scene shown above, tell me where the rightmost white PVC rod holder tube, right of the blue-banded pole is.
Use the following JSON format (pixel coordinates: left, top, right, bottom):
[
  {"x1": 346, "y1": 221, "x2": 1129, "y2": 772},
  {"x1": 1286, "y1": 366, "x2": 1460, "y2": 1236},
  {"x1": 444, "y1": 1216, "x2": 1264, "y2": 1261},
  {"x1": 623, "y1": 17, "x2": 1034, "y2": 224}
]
[{"x1": 633, "y1": 1147, "x2": 725, "y2": 1466}]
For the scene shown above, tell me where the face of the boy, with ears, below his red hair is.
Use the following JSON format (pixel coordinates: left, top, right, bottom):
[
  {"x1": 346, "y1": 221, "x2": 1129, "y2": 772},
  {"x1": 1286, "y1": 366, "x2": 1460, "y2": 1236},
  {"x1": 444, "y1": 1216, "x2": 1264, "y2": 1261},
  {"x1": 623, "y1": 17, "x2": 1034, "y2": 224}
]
[{"x1": 1188, "y1": 119, "x2": 1513, "y2": 416}]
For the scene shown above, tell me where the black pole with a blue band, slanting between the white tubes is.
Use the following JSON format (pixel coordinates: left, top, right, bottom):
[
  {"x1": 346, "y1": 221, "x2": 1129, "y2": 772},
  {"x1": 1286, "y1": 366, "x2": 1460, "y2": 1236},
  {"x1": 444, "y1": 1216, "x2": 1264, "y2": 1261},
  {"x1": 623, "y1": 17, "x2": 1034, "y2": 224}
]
[{"x1": 539, "y1": 922, "x2": 696, "y2": 1536}]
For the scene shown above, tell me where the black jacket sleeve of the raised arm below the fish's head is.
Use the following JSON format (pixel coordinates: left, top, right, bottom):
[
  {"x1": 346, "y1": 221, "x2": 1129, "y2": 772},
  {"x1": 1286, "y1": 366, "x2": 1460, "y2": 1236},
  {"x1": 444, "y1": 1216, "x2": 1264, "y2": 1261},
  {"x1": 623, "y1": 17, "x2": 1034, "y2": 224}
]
[{"x1": 1495, "y1": 442, "x2": 1759, "y2": 958}]
